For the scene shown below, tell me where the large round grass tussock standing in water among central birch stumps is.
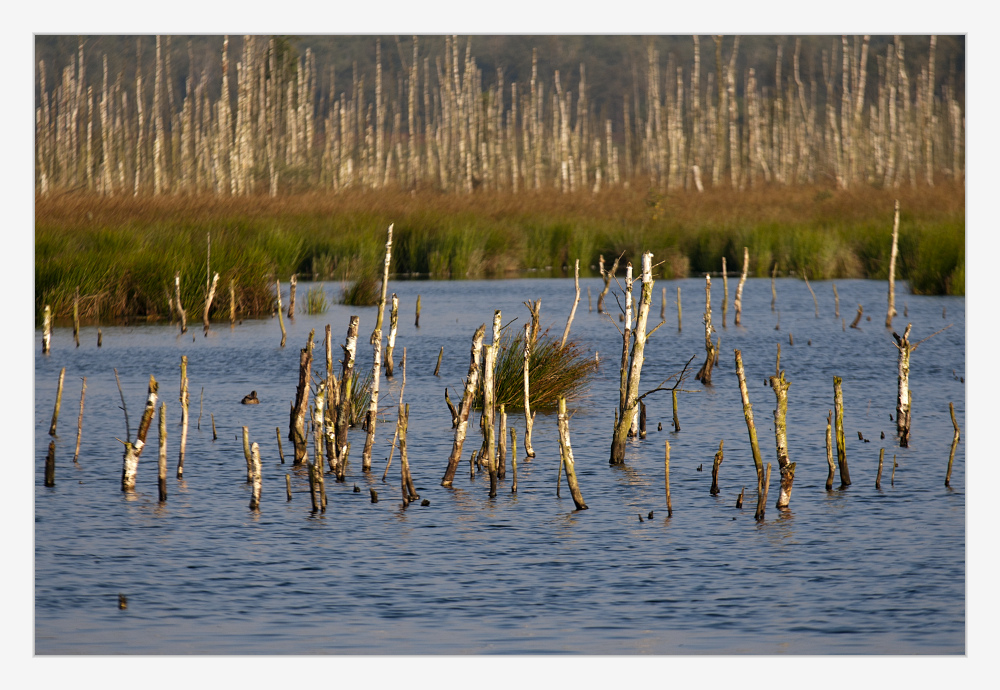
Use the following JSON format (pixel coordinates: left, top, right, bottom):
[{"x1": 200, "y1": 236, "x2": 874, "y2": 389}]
[{"x1": 473, "y1": 326, "x2": 594, "y2": 410}]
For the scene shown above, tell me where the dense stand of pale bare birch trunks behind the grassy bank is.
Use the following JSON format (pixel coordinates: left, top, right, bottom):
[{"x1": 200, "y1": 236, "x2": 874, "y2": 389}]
[{"x1": 35, "y1": 36, "x2": 965, "y2": 195}]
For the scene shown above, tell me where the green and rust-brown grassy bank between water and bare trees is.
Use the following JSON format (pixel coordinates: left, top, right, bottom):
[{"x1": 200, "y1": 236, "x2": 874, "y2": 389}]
[{"x1": 35, "y1": 184, "x2": 965, "y2": 320}]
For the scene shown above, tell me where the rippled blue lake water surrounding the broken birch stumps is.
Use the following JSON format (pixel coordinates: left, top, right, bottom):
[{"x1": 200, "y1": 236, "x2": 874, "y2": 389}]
[{"x1": 34, "y1": 277, "x2": 966, "y2": 654}]
